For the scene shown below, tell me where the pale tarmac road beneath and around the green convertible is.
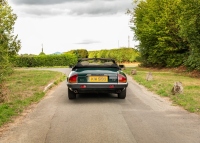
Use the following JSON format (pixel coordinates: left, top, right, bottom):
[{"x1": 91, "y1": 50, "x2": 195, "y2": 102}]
[{"x1": 0, "y1": 68, "x2": 200, "y2": 143}]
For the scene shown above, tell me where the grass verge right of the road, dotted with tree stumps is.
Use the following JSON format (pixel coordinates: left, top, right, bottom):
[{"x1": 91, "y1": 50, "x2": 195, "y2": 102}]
[{"x1": 124, "y1": 67, "x2": 200, "y2": 114}]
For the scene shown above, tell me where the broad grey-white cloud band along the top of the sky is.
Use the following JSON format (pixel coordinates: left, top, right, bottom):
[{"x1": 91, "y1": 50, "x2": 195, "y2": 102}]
[{"x1": 11, "y1": 0, "x2": 132, "y2": 16}]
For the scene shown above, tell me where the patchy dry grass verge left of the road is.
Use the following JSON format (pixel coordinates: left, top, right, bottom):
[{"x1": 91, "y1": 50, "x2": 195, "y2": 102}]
[{"x1": 0, "y1": 69, "x2": 65, "y2": 126}]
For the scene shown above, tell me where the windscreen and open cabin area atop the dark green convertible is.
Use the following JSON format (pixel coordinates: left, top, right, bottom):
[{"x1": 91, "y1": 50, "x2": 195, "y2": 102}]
[{"x1": 72, "y1": 58, "x2": 121, "y2": 70}]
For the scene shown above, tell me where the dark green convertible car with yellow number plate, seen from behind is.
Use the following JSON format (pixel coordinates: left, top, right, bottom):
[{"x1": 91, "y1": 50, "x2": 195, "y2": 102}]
[{"x1": 67, "y1": 58, "x2": 128, "y2": 99}]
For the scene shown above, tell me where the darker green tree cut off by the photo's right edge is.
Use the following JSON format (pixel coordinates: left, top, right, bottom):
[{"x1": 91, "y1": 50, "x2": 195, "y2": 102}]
[{"x1": 179, "y1": 0, "x2": 200, "y2": 71}]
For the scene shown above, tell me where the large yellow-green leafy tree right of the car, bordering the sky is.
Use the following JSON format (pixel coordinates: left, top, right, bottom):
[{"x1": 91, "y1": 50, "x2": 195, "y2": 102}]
[{"x1": 129, "y1": 0, "x2": 189, "y2": 67}]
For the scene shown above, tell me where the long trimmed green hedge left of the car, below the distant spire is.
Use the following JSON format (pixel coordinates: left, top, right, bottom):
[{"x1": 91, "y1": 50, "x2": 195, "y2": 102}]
[{"x1": 10, "y1": 54, "x2": 77, "y2": 67}]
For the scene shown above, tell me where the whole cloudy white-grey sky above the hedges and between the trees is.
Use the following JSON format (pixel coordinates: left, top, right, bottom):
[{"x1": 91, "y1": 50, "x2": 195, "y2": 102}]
[{"x1": 8, "y1": 0, "x2": 137, "y2": 54}]
